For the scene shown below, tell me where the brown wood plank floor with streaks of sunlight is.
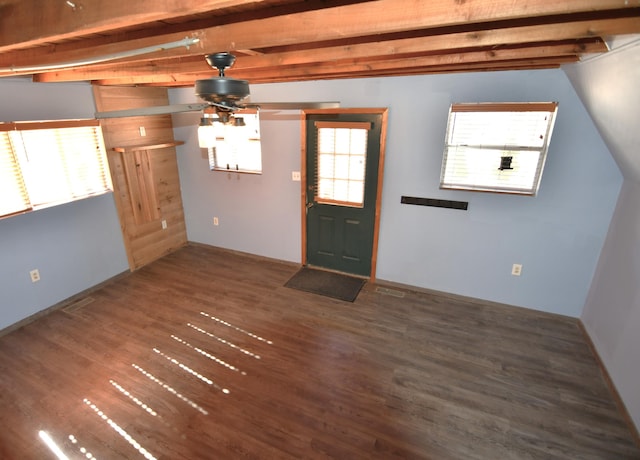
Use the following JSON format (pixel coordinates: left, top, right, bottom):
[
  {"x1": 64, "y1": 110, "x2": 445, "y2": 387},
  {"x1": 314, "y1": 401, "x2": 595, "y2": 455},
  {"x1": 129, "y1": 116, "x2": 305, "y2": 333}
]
[{"x1": 0, "y1": 245, "x2": 640, "y2": 459}]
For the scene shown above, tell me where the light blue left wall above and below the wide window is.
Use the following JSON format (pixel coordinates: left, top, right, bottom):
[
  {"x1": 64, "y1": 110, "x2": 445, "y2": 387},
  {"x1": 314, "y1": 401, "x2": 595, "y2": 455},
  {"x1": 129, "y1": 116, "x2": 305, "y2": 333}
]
[{"x1": 0, "y1": 79, "x2": 128, "y2": 329}]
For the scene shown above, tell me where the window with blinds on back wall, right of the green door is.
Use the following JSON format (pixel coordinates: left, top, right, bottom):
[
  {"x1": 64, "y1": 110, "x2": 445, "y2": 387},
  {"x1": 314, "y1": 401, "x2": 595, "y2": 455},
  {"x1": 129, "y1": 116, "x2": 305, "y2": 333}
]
[{"x1": 440, "y1": 102, "x2": 558, "y2": 195}]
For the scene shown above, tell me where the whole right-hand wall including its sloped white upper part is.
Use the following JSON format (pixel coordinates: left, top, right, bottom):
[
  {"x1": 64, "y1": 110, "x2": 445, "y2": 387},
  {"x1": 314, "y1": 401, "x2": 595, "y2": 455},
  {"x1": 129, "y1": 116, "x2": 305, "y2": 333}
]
[{"x1": 565, "y1": 36, "x2": 640, "y2": 427}]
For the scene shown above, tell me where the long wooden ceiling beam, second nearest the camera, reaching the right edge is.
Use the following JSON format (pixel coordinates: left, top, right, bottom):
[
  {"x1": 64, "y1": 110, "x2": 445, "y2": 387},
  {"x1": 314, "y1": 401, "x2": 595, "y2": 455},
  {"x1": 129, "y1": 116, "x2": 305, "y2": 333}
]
[{"x1": 0, "y1": 0, "x2": 640, "y2": 73}]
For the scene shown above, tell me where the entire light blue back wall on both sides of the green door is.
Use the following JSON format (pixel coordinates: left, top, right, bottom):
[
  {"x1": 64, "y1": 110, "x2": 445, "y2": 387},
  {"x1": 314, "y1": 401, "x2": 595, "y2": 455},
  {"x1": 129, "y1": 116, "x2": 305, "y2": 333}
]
[{"x1": 170, "y1": 70, "x2": 622, "y2": 317}]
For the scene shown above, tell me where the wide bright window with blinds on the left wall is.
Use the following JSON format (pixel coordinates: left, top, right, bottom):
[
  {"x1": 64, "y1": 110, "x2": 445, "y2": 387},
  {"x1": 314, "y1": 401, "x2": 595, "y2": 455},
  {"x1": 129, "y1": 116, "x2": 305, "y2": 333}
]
[{"x1": 0, "y1": 120, "x2": 113, "y2": 217}]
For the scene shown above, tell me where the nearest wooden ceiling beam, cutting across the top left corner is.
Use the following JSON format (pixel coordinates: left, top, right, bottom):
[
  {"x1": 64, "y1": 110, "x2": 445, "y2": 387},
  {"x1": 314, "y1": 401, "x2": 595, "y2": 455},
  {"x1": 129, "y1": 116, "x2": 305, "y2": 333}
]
[{"x1": 0, "y1": 0, "x2": 265, "y2": 52}]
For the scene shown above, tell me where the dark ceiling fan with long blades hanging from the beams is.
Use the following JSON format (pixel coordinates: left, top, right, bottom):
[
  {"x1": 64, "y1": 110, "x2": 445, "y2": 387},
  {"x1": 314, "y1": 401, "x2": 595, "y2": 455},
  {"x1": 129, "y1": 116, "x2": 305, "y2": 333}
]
[{"x1": 95, "y1": 52, "x2": 340, "y2": 124}]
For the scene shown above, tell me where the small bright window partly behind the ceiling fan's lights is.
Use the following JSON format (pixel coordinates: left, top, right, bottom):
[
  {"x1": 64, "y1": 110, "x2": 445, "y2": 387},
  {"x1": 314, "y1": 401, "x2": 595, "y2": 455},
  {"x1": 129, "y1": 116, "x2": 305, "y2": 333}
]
[{"x1": 207, "y1": 111, "x2": 262, "y2": 174}]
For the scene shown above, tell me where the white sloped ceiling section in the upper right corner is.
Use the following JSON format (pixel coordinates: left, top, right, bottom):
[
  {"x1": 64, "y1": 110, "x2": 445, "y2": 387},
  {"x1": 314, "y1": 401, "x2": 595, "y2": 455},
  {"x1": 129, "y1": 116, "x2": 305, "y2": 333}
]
[{"x1": 564, "y1": 35, "x2": 640, "y2": 183}]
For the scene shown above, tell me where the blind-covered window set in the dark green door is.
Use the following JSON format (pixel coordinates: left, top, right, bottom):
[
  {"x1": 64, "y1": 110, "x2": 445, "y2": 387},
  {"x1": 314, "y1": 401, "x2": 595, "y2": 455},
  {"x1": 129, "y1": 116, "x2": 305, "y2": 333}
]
[{"x1": 315, "y1": 121, "x2": 371, "y2": 207}]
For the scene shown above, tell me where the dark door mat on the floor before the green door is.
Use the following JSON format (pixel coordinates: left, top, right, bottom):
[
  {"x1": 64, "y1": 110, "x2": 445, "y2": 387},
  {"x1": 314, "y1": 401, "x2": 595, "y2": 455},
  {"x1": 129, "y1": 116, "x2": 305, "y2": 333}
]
[{"x1": 285, "y1": 267, "x2": 366, "y2": 302}]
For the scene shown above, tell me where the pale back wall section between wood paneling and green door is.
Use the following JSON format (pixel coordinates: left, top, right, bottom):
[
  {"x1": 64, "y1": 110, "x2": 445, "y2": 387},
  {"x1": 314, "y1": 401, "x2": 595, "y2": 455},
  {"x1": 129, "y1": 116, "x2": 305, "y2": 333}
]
[{"x1": 170, "y1": 107, "x2": 301, "y2": 262}]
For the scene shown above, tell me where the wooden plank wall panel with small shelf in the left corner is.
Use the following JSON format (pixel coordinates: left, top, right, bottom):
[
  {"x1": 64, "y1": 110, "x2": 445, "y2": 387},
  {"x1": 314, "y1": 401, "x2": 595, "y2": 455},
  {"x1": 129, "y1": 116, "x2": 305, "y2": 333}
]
[{"x1": 94, "y1": 86, "x2": 187, "y2": 270}]
